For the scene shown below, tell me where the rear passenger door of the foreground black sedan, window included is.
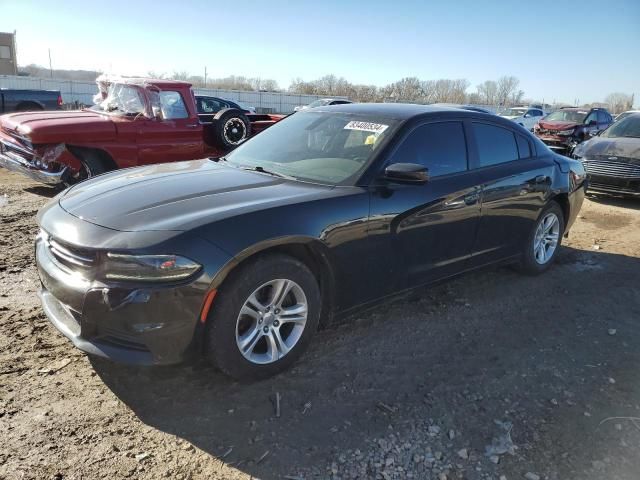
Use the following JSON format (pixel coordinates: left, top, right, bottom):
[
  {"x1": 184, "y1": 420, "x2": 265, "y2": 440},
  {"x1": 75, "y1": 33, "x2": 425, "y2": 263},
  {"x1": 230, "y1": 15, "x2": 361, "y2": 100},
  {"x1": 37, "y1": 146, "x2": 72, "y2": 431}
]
[{"x1": 470, "y1": 120, "x2": 554, "y2": 266}]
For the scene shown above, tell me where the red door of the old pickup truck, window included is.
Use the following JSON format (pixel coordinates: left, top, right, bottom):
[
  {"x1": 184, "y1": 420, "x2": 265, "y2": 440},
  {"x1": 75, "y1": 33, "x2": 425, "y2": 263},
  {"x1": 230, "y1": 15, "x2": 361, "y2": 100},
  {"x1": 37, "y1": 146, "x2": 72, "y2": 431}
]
[{"x1": 138, "y1": 90, "x2": 204, "y2": 164}]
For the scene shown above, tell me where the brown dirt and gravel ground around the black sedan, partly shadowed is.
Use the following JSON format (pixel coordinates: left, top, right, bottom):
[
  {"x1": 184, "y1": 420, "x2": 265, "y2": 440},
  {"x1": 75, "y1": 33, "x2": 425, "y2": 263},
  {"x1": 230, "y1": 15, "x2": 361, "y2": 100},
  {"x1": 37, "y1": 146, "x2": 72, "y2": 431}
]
[{"x1": 0, "y1": 170, "x2": 640, "y2": 480}]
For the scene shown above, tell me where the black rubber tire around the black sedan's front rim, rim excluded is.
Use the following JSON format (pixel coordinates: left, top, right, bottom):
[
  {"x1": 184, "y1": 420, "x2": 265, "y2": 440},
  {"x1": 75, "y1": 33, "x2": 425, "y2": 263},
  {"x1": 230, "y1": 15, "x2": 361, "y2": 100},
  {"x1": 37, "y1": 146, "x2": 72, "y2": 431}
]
[{"x1": 204, "y1": 254, "x2": 321, "y2": 380}]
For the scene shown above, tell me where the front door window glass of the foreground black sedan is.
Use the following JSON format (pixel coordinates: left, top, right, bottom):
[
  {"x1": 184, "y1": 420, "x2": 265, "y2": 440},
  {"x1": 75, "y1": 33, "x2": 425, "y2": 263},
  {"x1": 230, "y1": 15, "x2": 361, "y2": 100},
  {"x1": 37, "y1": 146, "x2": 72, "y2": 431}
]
[{"x1": 391, "y1": 122, "x2": 467, "y2": 177}]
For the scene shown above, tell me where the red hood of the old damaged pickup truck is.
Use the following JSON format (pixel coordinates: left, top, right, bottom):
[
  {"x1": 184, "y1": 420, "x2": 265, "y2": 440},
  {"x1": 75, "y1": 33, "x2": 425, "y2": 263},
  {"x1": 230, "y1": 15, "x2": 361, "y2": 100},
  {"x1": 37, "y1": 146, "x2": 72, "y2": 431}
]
[{"x1": 0, "y1": 110, "x2": 116, "y2": 144}]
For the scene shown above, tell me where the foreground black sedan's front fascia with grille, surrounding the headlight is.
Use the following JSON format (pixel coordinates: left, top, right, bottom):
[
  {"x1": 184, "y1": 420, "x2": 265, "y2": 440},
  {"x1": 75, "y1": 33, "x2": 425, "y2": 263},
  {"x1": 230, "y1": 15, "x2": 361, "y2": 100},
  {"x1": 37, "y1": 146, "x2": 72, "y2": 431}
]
[{"x1": 35, "y1": 199, "x2": 231, "y2": 365}]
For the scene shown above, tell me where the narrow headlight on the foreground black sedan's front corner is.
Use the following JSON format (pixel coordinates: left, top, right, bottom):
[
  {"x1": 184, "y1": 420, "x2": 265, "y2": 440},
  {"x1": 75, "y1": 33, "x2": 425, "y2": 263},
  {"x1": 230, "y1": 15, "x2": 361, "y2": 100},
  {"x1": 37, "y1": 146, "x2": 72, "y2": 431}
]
[{"x1": 104, "y1": 253, "x2": 202, "y2": 282}]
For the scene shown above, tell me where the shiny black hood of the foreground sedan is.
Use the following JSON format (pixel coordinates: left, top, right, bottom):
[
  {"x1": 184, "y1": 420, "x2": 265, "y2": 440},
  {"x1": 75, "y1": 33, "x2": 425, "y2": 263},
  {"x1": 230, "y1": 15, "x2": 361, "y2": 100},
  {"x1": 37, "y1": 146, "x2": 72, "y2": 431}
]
[{"x1": 59, "y1": 160, "x2": 333, "y2": 232}]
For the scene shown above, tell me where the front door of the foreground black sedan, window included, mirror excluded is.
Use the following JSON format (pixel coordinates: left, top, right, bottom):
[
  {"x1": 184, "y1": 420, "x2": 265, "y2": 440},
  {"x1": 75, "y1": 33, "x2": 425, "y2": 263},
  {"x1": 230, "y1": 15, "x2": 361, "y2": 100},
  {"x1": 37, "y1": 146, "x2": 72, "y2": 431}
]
[{"x1": 369, "y1": 119, "x2": 480, "y2": 290}]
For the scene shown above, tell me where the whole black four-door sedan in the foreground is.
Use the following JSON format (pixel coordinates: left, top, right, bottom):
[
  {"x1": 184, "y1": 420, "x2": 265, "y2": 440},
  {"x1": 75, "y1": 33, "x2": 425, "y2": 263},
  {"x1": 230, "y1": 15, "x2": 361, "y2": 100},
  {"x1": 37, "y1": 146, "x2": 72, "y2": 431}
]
[{"x1": 36, "y1": 104, "x2": 586, "y2": 378}]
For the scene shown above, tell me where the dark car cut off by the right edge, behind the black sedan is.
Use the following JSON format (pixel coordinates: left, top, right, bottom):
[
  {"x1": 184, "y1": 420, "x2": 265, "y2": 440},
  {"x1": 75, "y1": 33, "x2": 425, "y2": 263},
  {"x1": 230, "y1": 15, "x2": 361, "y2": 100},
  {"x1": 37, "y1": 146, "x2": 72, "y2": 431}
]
[{"x1": 573, "y1": 113, "x2": 640, "y2": 197}]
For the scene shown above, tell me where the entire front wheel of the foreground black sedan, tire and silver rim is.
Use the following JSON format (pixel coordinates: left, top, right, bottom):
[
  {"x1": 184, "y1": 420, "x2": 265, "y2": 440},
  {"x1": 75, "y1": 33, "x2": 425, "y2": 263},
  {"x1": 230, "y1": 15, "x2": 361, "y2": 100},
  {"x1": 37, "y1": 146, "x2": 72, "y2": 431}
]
[{"x1": 205, "y1": 255, "x2": 321, "y2": 380}]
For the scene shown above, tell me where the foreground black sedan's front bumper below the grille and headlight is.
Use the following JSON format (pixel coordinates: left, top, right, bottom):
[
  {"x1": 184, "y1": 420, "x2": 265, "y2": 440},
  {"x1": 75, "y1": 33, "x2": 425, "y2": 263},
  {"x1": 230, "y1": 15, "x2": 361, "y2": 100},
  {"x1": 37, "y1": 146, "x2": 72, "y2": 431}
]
[{"x1": 36, "y1": 237, "x2": 206, "y2": 365}]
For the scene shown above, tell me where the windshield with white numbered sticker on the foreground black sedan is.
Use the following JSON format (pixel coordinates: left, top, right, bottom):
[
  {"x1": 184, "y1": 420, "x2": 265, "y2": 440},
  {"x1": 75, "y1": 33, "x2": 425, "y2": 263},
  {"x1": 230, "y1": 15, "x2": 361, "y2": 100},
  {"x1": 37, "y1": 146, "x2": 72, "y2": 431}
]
[{"x1": 226, "y1": 110, "x2": 398, "y2": 185}]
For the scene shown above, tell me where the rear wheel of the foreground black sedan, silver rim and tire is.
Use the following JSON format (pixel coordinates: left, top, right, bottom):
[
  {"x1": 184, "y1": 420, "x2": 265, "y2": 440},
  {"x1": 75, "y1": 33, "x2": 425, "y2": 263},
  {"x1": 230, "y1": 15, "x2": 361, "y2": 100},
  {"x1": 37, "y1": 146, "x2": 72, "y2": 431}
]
[{"x1": 520, "y1": 201, "x2": 564, "y2": 274}]
